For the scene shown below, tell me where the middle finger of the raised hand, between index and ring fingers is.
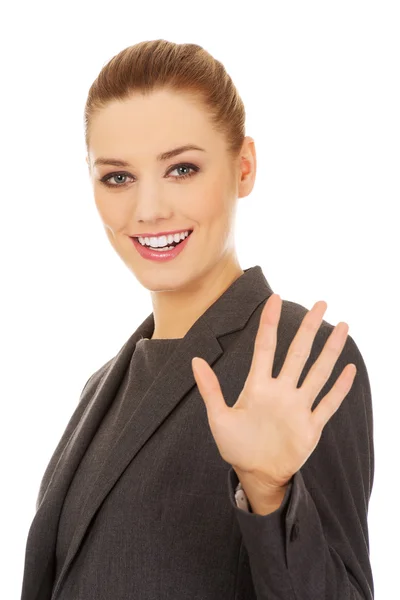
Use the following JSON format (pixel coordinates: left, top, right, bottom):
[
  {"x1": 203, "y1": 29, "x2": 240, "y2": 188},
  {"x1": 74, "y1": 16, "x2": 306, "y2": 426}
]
[{"x1": 278, "y1": 300, "x2": 328, "y2": 386}]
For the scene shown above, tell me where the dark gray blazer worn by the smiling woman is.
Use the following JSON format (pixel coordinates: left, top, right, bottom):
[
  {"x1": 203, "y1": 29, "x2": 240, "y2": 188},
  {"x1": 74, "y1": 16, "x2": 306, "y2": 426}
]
[{"x1": 21, "y1": 266, "x2": 374, "y2": 600}]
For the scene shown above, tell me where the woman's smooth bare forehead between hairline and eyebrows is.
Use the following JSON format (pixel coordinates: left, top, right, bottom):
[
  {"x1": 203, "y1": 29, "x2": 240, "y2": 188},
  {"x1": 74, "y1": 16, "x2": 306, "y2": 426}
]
[{"x1": 90, "y1": 90, "x2": 224, "y2": 156}]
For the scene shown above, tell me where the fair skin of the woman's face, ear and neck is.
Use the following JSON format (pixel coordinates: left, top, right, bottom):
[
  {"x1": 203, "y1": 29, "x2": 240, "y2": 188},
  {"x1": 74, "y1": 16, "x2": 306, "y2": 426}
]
[{"x1": 86, "y1": 89, "x2": 256, "y2": 339}]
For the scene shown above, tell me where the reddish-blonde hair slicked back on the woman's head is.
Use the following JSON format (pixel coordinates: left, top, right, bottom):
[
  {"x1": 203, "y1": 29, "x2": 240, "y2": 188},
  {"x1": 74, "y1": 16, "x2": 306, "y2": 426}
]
[{"x1": 84, "y1": 39, "x2": 245, "y2": 158}]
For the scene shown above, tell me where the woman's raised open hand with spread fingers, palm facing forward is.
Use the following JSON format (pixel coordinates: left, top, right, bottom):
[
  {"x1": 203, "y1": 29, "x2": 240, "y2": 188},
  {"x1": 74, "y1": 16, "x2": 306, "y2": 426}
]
[{"x1": 192, "y1": 294, "x2": 357, "y2": 490}]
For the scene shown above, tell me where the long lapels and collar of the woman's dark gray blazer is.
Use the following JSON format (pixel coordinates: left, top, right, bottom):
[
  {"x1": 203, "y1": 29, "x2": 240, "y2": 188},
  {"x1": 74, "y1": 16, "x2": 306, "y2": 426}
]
[{"x1": 22, "y1": 265, "x2": 273, "y2": 600}]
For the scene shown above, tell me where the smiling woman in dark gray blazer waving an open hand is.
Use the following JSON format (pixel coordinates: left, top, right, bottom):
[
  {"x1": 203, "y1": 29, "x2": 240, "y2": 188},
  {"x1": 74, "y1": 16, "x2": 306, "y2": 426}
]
[{"x1": 22, "y1": 40, "x2": 374, "y2": 600}]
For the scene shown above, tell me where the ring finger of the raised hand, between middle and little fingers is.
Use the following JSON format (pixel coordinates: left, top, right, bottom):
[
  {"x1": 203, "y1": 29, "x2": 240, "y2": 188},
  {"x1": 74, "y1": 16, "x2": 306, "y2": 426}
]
[{"x1": 301, "y1": 322, "x2": 349, "y2": 408}]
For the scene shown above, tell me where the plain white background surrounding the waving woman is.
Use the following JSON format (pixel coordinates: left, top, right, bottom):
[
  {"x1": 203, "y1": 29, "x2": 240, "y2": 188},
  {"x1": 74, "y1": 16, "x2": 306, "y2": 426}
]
[{"x1": 0, "y1": 0, "x2": 400, "y2": 600}]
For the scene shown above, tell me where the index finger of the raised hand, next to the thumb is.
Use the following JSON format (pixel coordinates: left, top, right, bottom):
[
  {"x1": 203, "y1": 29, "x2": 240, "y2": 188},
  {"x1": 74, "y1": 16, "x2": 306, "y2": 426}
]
[{"x1": 248, "y1": 294, "x2": 282, "y2": 383}]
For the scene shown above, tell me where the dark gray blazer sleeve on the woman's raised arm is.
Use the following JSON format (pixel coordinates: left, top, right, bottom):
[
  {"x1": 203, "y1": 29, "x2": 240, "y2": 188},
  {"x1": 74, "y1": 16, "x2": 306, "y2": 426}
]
[{"x1": 228, "y1": 335, "x2": 374, "y2": 600}]
